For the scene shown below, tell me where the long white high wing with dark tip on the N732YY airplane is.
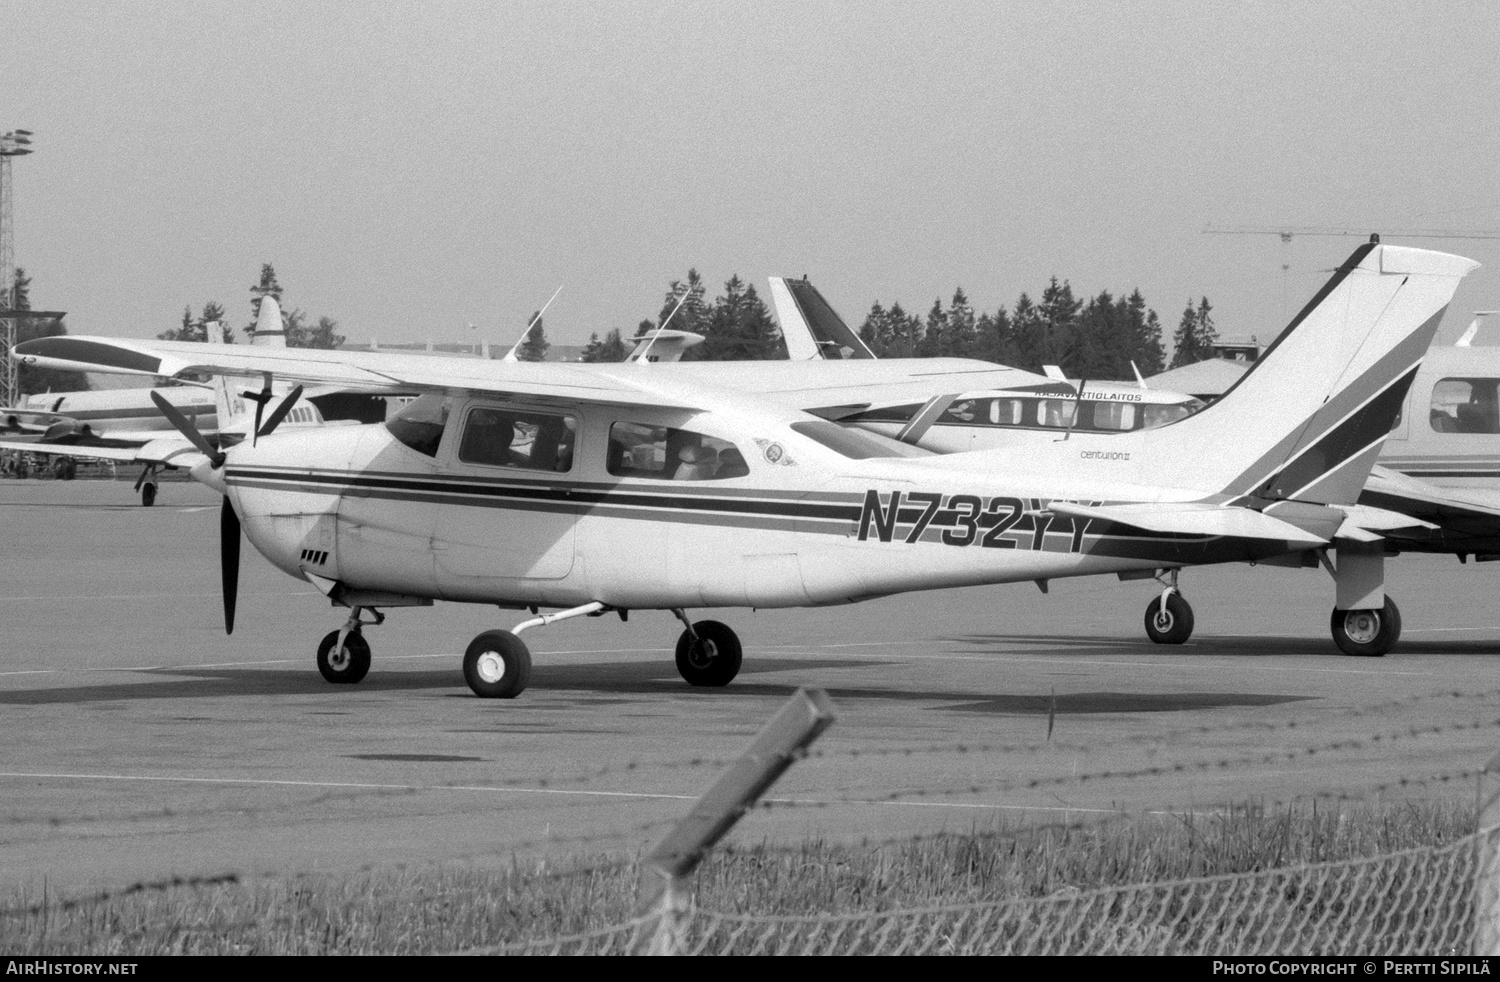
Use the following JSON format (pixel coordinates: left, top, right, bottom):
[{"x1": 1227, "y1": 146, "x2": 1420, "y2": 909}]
[{"x1": 15, "y1": 336, "x2": 698, "y2": 409}]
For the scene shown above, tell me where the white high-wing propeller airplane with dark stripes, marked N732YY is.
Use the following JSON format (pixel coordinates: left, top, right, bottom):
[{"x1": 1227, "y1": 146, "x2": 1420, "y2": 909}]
[{"x1": 17, "y1": 244, "x2": 1476, "y2": 697}]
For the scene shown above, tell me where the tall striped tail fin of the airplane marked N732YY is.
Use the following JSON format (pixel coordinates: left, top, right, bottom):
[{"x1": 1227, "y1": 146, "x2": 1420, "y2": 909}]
[{"x1": 1142, "y1": 241, "x2": 1479, "y2": 504}]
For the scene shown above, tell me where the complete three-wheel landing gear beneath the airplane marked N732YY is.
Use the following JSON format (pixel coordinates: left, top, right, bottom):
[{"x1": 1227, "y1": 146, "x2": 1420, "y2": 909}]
[{"x1": 309, "y1": 601, "x2": 744, "y2": 699}]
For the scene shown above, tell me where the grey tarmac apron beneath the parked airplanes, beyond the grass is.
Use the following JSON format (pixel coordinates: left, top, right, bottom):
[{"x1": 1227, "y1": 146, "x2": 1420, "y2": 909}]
[{"x1": 0, "y1": 480, "x2": 1500, "y2": 897}]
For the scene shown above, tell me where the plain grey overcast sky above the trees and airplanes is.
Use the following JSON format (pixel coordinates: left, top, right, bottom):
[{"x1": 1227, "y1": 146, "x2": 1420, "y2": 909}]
[{"x1": 0, "y1": 0, "x2": 1500, "y2": 353}]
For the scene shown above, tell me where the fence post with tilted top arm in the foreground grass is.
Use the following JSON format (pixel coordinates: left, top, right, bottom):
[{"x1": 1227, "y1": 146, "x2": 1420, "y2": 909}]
[{"x1": 645, "y1": 688, "x2": 834, "y2": 955}]
